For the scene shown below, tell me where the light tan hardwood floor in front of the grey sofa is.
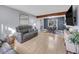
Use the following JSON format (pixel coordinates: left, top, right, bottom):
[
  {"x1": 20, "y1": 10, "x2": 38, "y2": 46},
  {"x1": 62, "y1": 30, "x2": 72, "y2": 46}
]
[{"x1": 14, "y1": 32, "x2": 66, "y2": 54}]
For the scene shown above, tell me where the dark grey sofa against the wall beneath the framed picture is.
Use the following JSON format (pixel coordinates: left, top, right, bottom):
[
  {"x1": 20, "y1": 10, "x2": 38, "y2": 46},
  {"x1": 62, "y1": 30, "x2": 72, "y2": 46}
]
[{"x1": 16, "y1": 25, "x2": 38, "y2": 43}]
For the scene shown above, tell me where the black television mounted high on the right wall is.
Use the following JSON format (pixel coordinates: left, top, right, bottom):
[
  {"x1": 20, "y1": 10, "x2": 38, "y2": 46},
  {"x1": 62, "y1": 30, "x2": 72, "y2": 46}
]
[{"x1": 66, "y1": 6, "x2": 76, "y2": 26}]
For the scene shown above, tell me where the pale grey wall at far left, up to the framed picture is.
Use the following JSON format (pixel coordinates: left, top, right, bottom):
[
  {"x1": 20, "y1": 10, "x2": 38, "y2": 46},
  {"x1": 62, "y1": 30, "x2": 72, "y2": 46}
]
[{"x1": 0, "y1": 6, "x2": 19, "y2": 36}]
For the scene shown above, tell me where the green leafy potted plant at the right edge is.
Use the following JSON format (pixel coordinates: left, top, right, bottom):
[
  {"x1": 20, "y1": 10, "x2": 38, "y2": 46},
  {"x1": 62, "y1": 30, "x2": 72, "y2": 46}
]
[{"x1": 70, "y1": 32, "x2": 79, "y2": 53}]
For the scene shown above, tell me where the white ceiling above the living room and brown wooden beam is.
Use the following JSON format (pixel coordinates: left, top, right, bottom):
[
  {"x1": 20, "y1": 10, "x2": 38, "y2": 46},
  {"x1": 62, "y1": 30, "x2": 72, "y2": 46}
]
[{"x1": 7, "y1": 5, "x2": 70, "y2": 16}]
